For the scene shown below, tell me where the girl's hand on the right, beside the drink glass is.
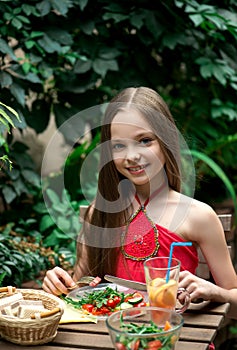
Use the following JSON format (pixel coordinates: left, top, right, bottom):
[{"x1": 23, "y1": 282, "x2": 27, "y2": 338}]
[{"x1": 179, "y1": 271, "x2": 219, "y2": 301}]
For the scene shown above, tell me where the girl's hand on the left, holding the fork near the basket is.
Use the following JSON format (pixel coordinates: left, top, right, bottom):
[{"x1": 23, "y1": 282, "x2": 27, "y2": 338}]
[{"x1": 42, "y1": 266, "x2": 75, "y2": 295}]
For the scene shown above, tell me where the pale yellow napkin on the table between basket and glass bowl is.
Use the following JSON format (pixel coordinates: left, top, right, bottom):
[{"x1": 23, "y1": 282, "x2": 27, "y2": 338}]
[{"x1": 59, "y1": 303, "x2": 97, "y2": 324}]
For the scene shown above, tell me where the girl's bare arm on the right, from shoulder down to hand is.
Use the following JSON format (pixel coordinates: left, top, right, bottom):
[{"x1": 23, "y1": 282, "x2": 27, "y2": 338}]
[{"x1": 180, "y1": 202, "x2": 237, "y2": 317}]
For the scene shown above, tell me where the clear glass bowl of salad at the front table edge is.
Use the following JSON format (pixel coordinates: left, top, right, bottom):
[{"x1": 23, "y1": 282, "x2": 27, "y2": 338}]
[{"x1": 106, "y1": 306, "x2": 184, "y2": 350}]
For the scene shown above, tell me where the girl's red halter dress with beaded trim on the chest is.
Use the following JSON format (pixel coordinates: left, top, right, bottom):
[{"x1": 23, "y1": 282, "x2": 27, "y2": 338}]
[{"x1": 116, "y1": 189, "x2": 198, "y2": 282}]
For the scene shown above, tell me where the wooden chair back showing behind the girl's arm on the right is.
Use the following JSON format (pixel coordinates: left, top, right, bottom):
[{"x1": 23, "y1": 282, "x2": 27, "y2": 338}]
[{"x1": 196, "y1": 214, "x2": 234, "y2": 280}]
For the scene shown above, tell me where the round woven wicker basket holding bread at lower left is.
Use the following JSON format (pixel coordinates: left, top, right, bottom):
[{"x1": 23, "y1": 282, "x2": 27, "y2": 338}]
[{"x1": 0, "y1": 288, "x2": 63, "y2": 345}]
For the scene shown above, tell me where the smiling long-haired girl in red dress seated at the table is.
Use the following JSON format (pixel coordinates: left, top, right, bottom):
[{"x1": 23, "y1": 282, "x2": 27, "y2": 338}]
[{"x1": 43, "y1": 87, "x2": 237, "y2": 316}]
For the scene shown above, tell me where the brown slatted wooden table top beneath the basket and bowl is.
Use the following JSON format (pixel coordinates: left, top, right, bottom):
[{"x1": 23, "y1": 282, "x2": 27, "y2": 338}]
[{"x1": 0, "y1": 303, "x2": 229, "y2": 350}]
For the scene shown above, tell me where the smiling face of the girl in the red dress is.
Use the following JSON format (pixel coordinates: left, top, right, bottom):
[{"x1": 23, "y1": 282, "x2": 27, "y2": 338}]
[{"x1": 111, "y1": 109, "x2": 165, "y2": 190}]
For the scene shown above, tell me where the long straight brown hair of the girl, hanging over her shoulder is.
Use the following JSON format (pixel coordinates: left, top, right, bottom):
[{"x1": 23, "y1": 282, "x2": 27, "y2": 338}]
[{"x1": 77, "y1": 87, "x2": 181, "y2": 277}]
